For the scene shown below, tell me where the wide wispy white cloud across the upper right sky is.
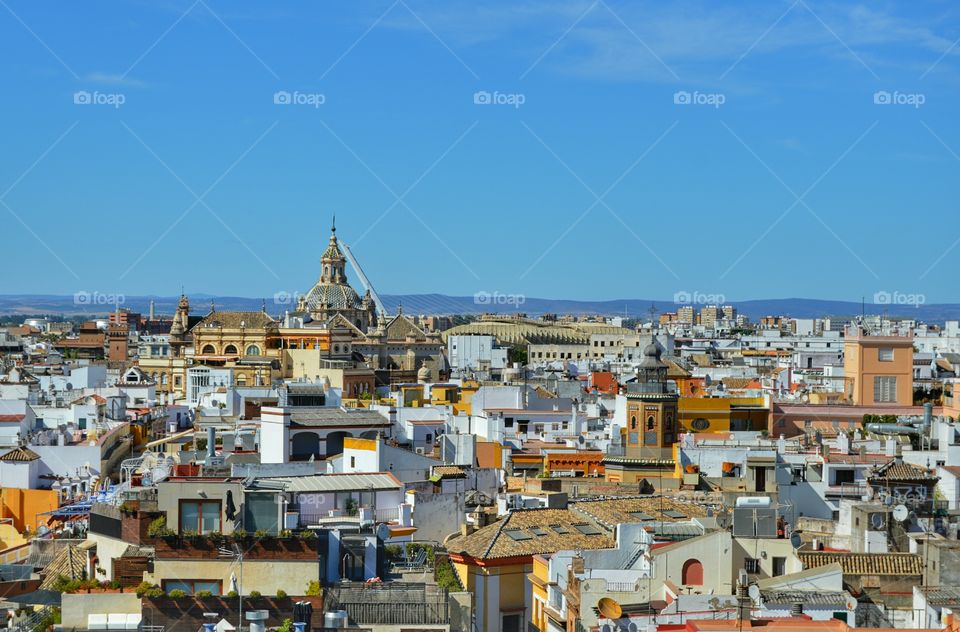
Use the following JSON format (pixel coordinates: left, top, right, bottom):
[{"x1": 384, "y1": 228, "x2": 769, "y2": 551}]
[{"x1": 372, "y1": 0, "x2": 960, "y2": 81}]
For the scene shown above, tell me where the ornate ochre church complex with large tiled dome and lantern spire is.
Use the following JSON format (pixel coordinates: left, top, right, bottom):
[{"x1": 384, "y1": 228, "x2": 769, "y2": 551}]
[{"x1": 140, "y1": 227, "x2": 448, "y2": 400}]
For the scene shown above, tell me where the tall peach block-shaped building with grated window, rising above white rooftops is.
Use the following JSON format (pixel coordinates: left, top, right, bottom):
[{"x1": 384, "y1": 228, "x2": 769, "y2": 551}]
[{"x1": 843, "y1": 327, "x2": 913, "y2": 406}]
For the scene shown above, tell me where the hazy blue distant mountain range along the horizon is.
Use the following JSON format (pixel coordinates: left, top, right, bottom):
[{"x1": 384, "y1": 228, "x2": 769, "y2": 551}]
[{"x1": 0, "y1": 292, "x2": 948, "y2": 323}]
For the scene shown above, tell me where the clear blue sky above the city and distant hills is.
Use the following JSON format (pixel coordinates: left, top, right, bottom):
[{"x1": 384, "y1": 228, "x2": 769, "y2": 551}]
[{"x1": 0, "y1": 0, "x2": 960, "y2": 303}]
